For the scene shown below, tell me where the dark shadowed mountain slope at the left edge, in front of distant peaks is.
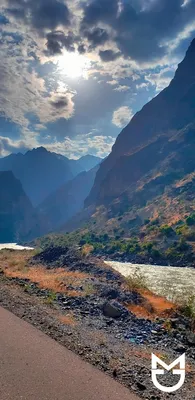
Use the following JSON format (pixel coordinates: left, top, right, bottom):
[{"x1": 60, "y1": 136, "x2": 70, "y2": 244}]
[{"x1": 0, "y1": 171, "x2": 44, "y2": 243}]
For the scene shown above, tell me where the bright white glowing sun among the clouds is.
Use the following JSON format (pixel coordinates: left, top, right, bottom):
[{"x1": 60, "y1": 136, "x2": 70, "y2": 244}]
[{"x1": 57, "y1": 52, "x2": 91, "y2": 79}]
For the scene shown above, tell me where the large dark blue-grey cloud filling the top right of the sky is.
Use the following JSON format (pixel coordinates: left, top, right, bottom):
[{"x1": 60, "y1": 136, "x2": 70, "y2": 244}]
[{"x1": 82, "y1": 0, "x2": 195, "y2": 62}]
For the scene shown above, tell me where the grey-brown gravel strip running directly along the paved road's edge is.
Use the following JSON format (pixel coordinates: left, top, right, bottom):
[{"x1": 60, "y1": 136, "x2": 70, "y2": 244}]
[{"x1": 0, "y1": 274, "x2": 195, "y2": 400}]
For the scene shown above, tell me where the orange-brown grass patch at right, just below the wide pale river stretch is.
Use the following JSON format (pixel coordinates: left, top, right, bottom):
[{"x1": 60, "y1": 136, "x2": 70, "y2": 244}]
[{"x1": 127, "y1": 290, "x2": 176, "y2": 320}]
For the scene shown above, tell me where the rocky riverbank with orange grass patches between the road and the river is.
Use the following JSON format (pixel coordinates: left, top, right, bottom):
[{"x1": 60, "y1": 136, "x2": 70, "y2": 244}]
[{"x1": 0, "y1": 247, "x2": 195, "y2": 400}]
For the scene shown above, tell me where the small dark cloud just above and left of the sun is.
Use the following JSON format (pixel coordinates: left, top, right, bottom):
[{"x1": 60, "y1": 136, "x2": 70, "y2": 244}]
[{"x1": 47, "y1": 31, "x2": 78, "y2": 55}]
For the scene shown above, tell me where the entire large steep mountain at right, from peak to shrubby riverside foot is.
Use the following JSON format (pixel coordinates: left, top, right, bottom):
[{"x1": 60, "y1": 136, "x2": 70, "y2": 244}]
[{"x1": 60, "y1": 40, "x2": 195, "y2": 266}]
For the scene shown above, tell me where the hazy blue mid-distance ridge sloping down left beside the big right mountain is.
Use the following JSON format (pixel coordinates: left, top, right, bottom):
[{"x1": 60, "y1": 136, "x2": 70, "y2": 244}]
[{"x1": 38, "y1": 166, "x2": 99, "y2": 230}]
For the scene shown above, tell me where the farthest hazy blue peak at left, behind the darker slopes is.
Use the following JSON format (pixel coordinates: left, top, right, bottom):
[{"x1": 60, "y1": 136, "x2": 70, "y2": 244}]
[{"x1": 0, "y1": 147, "x2": 75, "y2": 206}]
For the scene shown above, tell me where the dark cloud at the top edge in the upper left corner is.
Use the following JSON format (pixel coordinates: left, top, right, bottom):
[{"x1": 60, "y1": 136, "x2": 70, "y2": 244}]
[{"x1": 7, "y1": 0, "x2": 71, "y2": 31}]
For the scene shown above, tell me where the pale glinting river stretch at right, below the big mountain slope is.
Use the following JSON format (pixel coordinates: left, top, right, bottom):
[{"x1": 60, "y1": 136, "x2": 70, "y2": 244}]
[{"x1": 106, "y1": 261, "x2": 195, "y2": 301}]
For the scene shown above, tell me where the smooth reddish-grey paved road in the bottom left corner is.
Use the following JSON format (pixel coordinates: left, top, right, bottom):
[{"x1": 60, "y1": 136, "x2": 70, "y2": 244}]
[{"x1": 0, "y1": 307, "x2": 139, "y2": 400}]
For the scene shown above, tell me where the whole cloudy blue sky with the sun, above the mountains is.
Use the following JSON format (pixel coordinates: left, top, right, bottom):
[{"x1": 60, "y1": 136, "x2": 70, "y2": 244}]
[{"x1": 0, "y1": 0, "x2": 195, "y2": 158}]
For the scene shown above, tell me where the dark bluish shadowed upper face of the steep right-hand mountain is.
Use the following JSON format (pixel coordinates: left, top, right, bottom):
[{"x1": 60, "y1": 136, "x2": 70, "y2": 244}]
[{"x1": 85, "y1": 39, "x2": 195, "y2": 206}]
